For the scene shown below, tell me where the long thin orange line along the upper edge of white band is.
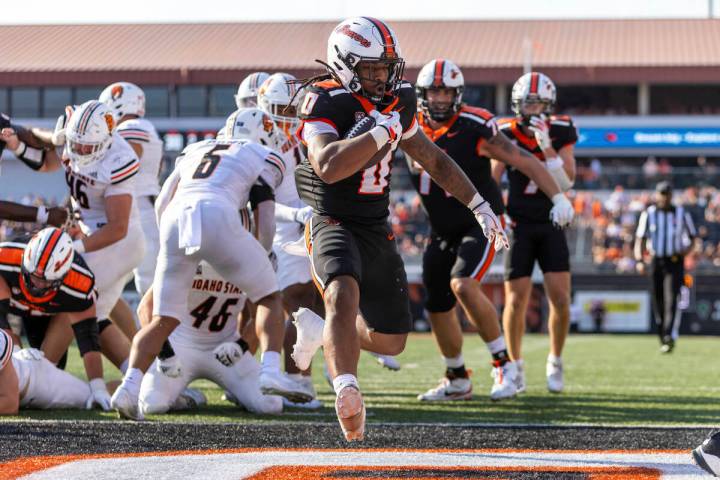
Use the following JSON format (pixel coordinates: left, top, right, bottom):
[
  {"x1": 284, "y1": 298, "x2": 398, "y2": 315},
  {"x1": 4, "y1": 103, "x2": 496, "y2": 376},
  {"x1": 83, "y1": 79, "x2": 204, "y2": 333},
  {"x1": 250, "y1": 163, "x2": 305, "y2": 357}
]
[{"x1": 0, "y1": 448, "x2": 687, "y2": 480}]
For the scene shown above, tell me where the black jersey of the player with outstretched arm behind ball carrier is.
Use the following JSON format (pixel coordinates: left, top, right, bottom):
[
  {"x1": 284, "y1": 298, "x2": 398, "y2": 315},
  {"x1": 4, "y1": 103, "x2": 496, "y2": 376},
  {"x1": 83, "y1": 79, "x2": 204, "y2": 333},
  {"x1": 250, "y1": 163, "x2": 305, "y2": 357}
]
[{"x1": 406, "y1": 106, "x2": 505, "y2": 237}]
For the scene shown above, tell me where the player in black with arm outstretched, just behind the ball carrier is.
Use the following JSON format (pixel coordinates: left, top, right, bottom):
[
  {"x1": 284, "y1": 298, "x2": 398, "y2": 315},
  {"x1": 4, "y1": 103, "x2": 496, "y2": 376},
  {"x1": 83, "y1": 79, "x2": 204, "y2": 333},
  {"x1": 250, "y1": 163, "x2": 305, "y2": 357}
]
[{"x1": 407, "y1": 59, "x2": 572, "y2": 401}]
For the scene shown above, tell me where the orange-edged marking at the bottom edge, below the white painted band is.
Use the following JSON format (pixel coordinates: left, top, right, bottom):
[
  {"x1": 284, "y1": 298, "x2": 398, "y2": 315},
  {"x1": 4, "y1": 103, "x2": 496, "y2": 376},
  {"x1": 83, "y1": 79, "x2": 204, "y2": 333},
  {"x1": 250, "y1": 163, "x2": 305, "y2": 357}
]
[{"x1": 248, "y1": 465, "x2": 661, "y2": 480}]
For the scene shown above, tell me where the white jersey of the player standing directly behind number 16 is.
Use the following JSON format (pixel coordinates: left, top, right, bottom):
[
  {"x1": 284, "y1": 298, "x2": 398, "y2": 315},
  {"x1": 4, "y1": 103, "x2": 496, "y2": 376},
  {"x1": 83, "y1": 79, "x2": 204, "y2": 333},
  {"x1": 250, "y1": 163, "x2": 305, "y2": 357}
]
[{"x1": 116, "y1": 118, "x2": 163, "y2": 196}]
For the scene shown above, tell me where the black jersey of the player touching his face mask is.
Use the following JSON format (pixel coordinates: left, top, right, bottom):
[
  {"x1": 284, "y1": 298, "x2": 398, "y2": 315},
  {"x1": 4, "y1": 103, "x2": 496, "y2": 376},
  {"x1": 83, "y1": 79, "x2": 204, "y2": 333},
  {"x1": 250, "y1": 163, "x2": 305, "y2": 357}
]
[{"x1": 498, "y1": 115, "x2": 578, "y2": 223}]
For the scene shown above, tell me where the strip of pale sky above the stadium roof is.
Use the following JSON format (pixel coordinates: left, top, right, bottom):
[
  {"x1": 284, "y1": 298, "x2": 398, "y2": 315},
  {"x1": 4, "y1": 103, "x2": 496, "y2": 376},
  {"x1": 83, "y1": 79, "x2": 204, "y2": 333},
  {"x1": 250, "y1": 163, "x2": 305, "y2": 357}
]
[{"x1": 0, "y1": 0, "x2": 720, "y2": 24}]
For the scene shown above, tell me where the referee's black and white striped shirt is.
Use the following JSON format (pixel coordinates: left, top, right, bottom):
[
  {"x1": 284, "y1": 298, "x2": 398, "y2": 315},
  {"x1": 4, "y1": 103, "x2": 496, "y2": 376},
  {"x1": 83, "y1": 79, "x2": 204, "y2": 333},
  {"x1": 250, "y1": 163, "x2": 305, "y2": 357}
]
[{"x1": 635, "y1": 205, "x2": 697, "y2": 258}]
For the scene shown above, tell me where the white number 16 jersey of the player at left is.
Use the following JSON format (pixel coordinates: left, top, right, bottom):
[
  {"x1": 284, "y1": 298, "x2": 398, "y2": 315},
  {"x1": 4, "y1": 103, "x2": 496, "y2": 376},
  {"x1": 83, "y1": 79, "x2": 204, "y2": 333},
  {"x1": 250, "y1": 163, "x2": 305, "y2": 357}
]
[{"x1": 65, "y1": 132, "x2": 140, "y2": 235}]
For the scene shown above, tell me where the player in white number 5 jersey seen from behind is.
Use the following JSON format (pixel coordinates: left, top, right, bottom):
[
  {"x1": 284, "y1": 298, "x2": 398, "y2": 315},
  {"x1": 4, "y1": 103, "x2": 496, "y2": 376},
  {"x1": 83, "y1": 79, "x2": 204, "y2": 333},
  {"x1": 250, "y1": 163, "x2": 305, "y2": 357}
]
[{"x1": 112, "y1": 109, "x2": 310, "y2": 420}]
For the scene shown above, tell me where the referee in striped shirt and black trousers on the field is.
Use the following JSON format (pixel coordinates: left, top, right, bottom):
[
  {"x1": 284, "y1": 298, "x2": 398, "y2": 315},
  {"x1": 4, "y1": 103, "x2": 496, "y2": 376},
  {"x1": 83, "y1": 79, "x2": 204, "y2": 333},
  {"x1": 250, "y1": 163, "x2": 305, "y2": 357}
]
[{"x1": 635, "y1": 182, "x2": 697, "y2": 353}]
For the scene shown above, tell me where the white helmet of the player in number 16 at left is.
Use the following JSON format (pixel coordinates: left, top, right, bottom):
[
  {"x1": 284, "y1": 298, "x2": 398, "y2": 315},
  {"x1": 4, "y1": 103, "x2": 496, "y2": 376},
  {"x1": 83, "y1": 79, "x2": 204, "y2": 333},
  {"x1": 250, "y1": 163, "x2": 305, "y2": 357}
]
[{"x1": 65, "y1": 100, "x2": 115, "y2": 166}]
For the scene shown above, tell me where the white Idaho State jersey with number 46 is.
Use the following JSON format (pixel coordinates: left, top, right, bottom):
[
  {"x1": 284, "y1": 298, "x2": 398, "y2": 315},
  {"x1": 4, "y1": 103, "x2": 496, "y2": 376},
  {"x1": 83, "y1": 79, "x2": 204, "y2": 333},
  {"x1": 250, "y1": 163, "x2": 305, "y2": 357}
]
[{"x1": 170, "y1": 261, "x2": 247, "y2": 350}]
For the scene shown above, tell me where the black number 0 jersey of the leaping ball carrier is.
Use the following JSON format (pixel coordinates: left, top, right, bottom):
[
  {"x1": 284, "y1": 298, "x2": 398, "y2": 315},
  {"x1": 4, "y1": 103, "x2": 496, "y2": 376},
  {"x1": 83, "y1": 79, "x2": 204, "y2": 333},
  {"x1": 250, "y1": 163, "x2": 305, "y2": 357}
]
[{"x1": 295, "y1": 81, "x2": 417, "y2": 225}]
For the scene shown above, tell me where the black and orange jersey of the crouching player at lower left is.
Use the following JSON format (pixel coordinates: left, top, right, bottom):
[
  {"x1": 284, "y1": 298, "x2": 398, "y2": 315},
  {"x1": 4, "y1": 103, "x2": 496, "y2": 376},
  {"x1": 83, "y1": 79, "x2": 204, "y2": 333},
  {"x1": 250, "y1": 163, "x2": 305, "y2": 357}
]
[{"x1": 0, "y1": 240, "x2": 96, "y2": 317}]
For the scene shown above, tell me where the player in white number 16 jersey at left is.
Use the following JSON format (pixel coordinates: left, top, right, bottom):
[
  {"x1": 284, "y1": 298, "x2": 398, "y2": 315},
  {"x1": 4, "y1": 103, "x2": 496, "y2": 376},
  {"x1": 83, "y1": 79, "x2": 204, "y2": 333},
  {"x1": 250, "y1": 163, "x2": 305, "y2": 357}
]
[{"x1": 4, "y1": 100, "x2": 145, "y2": 339}]
